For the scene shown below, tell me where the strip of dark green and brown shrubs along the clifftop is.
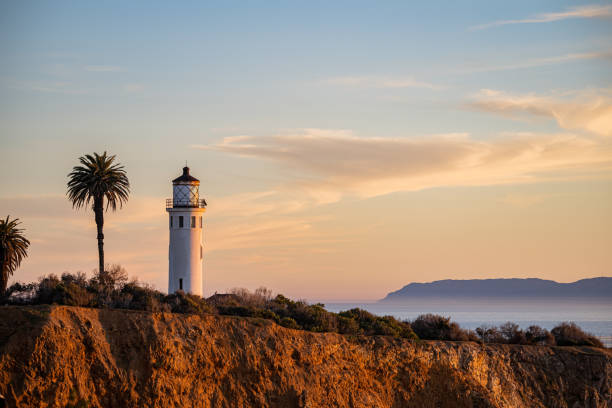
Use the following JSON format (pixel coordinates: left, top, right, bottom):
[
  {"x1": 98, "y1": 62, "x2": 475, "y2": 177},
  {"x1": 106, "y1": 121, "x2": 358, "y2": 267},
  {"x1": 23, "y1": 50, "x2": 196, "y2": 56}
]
[{"x1": 0, "y1": 265, "x2": 603, "y2": 347}]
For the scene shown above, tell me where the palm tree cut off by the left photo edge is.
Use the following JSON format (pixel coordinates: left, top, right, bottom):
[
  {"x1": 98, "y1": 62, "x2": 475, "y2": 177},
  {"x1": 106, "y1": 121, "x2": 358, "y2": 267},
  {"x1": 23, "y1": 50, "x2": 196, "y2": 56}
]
[{"x1": 0, "y1": 215, "x2": 30, "y2": 294}]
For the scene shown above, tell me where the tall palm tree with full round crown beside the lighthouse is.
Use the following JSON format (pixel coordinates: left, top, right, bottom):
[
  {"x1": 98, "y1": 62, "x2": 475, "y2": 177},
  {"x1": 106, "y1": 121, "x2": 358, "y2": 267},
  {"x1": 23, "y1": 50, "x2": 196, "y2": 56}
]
[{"x1": 67, "y1": 152, "x2": 130, "y2": 273}]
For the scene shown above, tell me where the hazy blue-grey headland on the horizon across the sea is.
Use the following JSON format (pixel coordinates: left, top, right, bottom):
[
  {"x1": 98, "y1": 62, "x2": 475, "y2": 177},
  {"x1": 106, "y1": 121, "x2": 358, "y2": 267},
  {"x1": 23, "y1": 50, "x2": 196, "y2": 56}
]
[{"x1": 380, "y1": 277, "x2": 612, "y2": 302}]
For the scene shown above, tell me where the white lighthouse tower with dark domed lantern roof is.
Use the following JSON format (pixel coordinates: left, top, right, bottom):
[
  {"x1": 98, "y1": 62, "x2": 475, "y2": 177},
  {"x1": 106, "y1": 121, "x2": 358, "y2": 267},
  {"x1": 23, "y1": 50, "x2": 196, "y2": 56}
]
[{"x1": 166, "y1": 166, "x2": 206, "y2": 296}]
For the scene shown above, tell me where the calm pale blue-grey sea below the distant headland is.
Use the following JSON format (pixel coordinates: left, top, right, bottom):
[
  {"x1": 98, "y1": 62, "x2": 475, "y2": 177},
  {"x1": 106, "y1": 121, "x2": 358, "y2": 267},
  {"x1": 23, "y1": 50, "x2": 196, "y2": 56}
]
[{"x1": 325, "y1": 298, "x2": 612, "y2": 347}]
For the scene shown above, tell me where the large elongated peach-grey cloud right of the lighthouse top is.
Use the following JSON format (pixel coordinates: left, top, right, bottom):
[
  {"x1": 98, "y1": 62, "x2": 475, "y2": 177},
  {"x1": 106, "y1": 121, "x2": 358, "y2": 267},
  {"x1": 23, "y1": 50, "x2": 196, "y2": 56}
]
[{"x1": 196, "y1": 129, "x2": 612, "y2": 203}]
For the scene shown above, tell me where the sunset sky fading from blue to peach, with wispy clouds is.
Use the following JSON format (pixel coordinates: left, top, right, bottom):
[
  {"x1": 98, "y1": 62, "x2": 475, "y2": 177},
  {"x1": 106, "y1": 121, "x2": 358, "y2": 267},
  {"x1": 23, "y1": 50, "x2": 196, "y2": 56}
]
[{"x1": 0, "y1": 1, "x2": 612, "y2": 301}]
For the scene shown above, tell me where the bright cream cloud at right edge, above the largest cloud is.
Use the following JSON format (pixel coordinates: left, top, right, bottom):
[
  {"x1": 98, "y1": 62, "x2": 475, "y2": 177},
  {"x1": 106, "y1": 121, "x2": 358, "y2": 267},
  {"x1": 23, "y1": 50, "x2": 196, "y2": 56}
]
[{"x1": 470, "y1": 89, "x2": 612, "y2": 136}]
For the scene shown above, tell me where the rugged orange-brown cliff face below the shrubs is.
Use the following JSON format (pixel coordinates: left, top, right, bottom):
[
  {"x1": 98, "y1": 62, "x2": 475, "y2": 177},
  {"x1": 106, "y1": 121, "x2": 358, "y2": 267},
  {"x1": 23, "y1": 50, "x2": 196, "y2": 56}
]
[{"x1": 0, "y1": 306, "x2": 612, "y2": 407}]
